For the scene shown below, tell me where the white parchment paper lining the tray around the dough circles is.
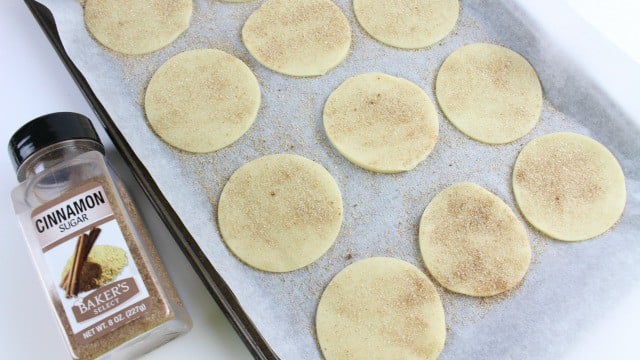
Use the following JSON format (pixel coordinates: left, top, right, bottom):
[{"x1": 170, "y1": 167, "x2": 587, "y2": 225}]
[{"x1": 36, "y1": 0, "x2": 640, "y2": 359}]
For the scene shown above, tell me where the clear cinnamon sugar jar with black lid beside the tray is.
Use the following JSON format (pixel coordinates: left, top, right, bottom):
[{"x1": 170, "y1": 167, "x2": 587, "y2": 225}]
[{"x1": 9, "y1": 113, "x2": 191, "y2": 359}]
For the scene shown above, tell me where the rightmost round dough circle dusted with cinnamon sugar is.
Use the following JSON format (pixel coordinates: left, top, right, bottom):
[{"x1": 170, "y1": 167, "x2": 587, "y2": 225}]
[{"x1": 513, "y1": 133, "x2": 626, "y2": 241}]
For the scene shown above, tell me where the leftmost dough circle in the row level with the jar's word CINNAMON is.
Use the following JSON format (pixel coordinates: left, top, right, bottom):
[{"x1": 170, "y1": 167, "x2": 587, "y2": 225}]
[{"x1": 218, "y1": 154, "x2": 342, "y2": 272}]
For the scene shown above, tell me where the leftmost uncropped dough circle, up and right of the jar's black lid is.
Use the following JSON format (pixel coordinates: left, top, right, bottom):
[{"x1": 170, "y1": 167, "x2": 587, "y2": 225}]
[{"x1": 145, "y1": 49, "x2": 260, "y2": 153}]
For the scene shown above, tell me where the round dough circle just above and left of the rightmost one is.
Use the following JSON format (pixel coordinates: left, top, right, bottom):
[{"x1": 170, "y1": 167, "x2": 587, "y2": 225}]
[{"x1": 436, "y1": 44, "x2": 542, "y2": 144}]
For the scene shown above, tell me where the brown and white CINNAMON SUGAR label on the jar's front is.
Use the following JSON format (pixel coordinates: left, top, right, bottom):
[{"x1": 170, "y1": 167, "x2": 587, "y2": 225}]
[{"x1": 31, "y1": 182, "x2": 151, "y2": 343}]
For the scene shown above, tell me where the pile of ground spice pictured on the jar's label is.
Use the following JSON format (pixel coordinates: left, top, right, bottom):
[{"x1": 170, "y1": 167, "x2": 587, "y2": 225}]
[{"x1": 61, "y1": 245, "x2": 129, "y2": 292}]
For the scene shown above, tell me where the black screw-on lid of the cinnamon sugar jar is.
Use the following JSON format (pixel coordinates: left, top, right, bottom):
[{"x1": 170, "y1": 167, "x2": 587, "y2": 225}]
[{"x1": 9, "y1": 112, "x2": 104, "y2": 174}]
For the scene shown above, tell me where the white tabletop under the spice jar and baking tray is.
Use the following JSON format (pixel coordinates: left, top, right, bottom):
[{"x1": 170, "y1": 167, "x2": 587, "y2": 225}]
[{"x1": 0, "y1": 0, "x2": 640, "y2": 360}]
